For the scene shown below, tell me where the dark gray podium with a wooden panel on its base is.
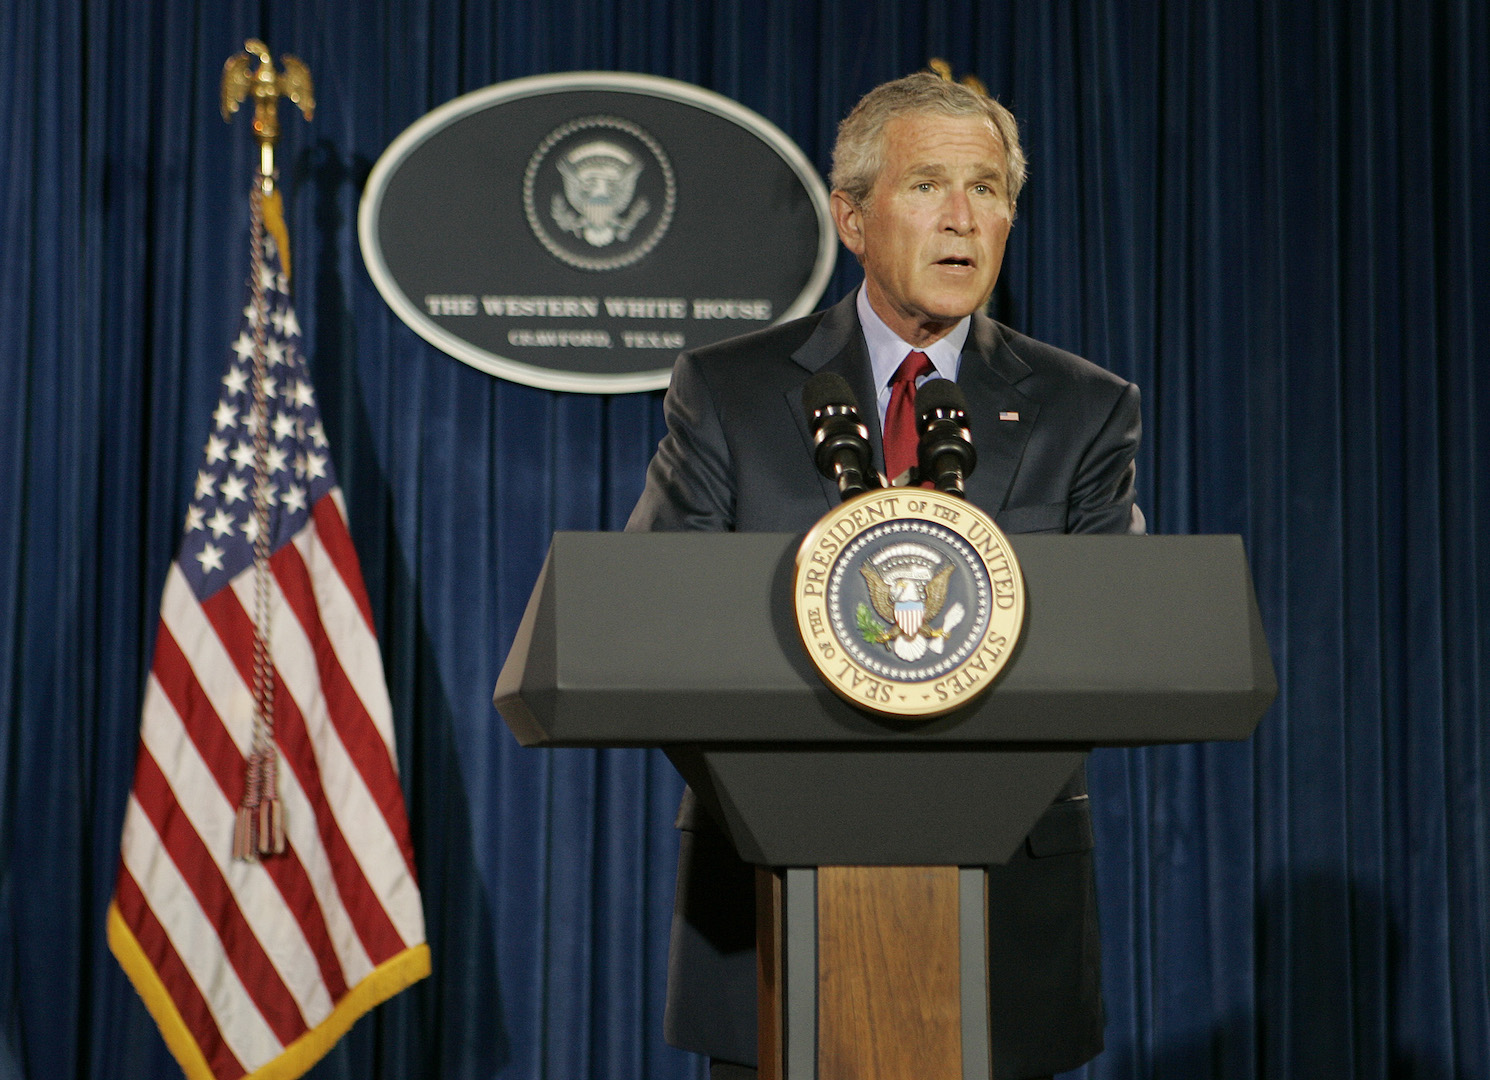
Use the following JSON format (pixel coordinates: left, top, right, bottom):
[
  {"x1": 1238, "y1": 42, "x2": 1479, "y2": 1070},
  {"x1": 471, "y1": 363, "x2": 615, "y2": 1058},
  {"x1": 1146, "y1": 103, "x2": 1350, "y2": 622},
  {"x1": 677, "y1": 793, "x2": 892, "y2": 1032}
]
[{"x1": 495, "y1": 533, "x2": 1277, "y2": 1080}]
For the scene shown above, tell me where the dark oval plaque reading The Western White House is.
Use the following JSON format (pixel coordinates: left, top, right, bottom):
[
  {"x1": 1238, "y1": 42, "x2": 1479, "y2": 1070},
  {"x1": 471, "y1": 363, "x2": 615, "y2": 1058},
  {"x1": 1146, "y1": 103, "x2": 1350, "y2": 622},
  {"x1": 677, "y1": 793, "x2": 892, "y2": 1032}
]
[{"x1": 358, "y1": 72, "x2": 837, "y2": 393}]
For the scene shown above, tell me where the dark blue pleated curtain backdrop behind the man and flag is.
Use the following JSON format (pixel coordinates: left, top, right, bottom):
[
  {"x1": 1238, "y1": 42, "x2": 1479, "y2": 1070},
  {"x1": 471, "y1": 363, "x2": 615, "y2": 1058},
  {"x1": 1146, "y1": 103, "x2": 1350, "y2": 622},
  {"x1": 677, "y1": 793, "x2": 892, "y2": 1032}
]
[{"x1": 0, "y1": 0, "x2": 1490, "y2": 1080}]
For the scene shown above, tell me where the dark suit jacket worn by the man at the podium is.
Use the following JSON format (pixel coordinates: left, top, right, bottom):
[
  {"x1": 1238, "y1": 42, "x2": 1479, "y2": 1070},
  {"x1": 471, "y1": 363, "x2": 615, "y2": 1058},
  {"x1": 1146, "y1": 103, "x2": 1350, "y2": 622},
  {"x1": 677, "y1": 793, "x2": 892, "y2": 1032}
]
[{"x1": 627, "y1": 295, "x2": 1143, "y2": 1080}]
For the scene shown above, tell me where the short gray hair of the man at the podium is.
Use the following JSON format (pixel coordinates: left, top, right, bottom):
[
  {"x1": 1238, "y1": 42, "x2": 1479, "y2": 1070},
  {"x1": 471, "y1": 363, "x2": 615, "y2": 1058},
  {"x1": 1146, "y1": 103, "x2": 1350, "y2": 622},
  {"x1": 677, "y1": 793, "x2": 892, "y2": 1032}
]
[{"x1": 830, "y1": 72, "x2": 1025, "y2": 212}]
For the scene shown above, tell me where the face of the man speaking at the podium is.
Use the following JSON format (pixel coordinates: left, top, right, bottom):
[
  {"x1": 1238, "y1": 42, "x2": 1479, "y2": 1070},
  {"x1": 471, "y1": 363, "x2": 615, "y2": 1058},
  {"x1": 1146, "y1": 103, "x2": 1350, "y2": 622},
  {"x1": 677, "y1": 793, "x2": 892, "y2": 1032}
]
[{"x1": 833, "y1": 113, "x2": 1012, "y2": 346}]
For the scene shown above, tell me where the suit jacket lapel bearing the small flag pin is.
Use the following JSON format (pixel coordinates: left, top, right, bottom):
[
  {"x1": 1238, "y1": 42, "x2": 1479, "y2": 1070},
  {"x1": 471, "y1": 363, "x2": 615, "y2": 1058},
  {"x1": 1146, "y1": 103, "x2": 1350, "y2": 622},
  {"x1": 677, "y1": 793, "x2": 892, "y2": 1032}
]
[{"x1": 957, "y1": 313, "x2": 1040, "y2": 514}]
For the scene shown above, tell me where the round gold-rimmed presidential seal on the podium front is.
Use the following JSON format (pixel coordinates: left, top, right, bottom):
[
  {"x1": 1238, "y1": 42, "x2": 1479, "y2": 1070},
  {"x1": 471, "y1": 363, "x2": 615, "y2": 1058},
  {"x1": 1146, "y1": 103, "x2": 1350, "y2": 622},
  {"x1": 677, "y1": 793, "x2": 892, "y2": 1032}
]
[{"x1": 793, "y1": 487, "x2": 1025, "y2": 718}]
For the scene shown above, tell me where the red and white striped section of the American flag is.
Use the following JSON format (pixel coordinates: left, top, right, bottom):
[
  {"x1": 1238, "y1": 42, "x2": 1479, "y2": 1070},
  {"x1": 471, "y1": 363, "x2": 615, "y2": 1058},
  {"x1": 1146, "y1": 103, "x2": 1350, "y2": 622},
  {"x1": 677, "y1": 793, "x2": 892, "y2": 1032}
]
[{"x1": 115, "y1": 489, "x2": 425, "y2": 1080}]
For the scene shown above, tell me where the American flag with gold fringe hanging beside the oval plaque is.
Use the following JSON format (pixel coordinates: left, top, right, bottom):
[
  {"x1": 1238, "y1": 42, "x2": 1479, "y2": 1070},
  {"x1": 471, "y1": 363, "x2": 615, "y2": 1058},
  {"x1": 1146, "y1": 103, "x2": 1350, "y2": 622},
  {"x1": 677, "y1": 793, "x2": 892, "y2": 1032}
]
[{"x1": 109, "y1": 189, "x2": 429, "y2": 1080}]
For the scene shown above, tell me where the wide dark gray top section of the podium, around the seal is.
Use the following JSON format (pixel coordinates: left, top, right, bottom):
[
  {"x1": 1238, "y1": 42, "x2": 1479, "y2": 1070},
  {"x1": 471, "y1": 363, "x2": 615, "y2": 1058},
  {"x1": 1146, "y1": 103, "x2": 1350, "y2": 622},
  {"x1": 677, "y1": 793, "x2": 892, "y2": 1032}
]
[{"x1": 495, "y1": 533, "x2": 1277, "y2": 746}]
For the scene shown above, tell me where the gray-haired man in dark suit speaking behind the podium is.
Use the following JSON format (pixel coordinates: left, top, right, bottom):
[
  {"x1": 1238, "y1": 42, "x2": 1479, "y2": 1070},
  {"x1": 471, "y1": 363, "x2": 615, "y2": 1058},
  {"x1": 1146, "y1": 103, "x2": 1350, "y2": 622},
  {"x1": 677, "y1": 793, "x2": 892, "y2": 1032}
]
[{"x1": 627, "y1": 73, "x2": 1143, "y2": 1080}]
